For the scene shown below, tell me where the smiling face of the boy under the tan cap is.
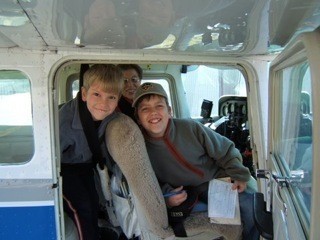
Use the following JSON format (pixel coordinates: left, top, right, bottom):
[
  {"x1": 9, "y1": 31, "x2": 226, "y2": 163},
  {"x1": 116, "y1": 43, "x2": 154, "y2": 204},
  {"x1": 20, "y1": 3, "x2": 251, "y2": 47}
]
[{"x1": 137, "y1": 95, "x2": 171, "y2": 138}]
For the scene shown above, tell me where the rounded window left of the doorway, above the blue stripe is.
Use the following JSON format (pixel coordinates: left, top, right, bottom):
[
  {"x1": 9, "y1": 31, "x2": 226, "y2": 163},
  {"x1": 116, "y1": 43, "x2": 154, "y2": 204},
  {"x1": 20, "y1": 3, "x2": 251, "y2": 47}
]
[{"x1": 0, "y1": 70, "x2": 34, "y2": 164}]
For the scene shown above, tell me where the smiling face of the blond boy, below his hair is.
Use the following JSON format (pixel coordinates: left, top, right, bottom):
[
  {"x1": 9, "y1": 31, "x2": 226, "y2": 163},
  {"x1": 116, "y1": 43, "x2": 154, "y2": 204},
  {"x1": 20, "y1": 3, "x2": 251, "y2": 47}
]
[{"x1": 81, "y1": 82, "x2": 119, "y2": 121}]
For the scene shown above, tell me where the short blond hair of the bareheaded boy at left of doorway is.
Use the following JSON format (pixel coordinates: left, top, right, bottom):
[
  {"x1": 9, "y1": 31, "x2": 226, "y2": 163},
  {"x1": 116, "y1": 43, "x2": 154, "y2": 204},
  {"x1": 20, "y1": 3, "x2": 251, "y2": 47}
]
[{"x1": 83, "y1": 64, "x2": 123, "y2": 96}]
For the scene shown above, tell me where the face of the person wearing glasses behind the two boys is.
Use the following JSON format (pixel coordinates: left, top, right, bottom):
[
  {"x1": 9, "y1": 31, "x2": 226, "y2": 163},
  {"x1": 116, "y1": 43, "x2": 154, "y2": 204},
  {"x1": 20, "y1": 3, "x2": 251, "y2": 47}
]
[{"x1": 122, "y1": 68, "x2": 141, "y2": 100}]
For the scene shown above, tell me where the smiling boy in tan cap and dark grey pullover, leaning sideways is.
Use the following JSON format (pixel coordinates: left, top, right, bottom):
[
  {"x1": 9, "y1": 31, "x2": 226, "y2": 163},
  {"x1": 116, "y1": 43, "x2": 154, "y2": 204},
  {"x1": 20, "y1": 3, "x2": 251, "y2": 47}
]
[{"x1": 133, "y1": 83, "x2": 259, "y2": 240}]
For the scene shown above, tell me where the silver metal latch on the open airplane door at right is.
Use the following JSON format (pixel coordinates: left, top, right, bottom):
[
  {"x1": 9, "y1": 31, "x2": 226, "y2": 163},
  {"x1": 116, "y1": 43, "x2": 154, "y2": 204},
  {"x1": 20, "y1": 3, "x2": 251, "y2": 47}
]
[{"x1": 256, "y1": 169, "x2": 305, "y2": 187}]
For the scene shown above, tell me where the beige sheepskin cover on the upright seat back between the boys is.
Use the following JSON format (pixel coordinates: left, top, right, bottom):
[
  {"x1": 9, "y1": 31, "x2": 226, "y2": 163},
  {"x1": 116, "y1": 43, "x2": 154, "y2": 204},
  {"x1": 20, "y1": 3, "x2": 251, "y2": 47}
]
[{"x1": 106, "y1": 114, "x2": 173, "y2": 238}]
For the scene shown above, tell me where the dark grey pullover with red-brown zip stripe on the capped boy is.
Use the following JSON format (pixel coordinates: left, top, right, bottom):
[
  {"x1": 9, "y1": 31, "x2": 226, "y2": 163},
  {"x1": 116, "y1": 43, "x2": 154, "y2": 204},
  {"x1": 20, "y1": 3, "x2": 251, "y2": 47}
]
[{"x1": 145, "y1": 119, "x2": 250, "y2": 191}]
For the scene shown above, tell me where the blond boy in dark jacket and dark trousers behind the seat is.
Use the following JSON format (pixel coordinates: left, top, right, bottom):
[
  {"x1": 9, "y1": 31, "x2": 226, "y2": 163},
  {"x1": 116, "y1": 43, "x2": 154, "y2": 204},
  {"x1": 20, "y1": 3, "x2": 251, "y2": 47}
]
[{"x1": 59, "y1": 64, "x2": 123, "y2": 240}]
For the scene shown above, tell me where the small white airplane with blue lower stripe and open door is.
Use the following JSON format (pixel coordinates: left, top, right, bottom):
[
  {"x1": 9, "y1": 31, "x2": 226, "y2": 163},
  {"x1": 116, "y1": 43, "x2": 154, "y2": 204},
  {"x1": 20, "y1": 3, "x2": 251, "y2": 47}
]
[{"x1": 0, "y1": 0, "x2": 320, "y2": 240}]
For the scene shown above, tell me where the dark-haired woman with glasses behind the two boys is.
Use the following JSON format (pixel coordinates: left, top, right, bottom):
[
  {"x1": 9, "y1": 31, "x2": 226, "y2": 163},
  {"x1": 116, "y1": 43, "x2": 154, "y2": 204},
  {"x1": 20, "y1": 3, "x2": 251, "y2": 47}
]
[{"x1": 118, "y1": 64, "x2": 143, "y2": 122}]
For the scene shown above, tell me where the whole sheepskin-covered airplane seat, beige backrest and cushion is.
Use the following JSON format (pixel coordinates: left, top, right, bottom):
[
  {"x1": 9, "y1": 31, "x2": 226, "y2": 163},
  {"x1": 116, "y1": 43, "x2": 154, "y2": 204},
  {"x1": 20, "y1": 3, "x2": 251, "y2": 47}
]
[{"x1": 106, "y1": 113, "x2": 246, "y2": 240}]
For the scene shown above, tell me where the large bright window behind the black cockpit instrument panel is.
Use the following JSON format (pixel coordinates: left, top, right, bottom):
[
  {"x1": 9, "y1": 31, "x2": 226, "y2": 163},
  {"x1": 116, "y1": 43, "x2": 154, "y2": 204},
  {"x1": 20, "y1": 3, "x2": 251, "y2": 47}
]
[{"x1": 182, "y1": 66, "x2": 247, "y2": 118}]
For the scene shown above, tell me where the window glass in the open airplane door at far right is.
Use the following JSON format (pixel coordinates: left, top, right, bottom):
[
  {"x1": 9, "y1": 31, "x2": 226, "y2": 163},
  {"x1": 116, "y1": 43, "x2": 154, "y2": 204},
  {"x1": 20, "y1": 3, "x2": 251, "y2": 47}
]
[{"x1": 277, "y1": 62, "x2": 313, "y2": 222}]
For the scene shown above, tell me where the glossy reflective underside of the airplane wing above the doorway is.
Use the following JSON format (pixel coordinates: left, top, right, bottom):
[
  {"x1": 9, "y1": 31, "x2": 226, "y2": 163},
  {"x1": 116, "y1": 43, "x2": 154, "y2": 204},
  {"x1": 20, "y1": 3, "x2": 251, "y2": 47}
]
[{"x1": 0, "y1": 0, "x2": 320, "y2": 55}]
